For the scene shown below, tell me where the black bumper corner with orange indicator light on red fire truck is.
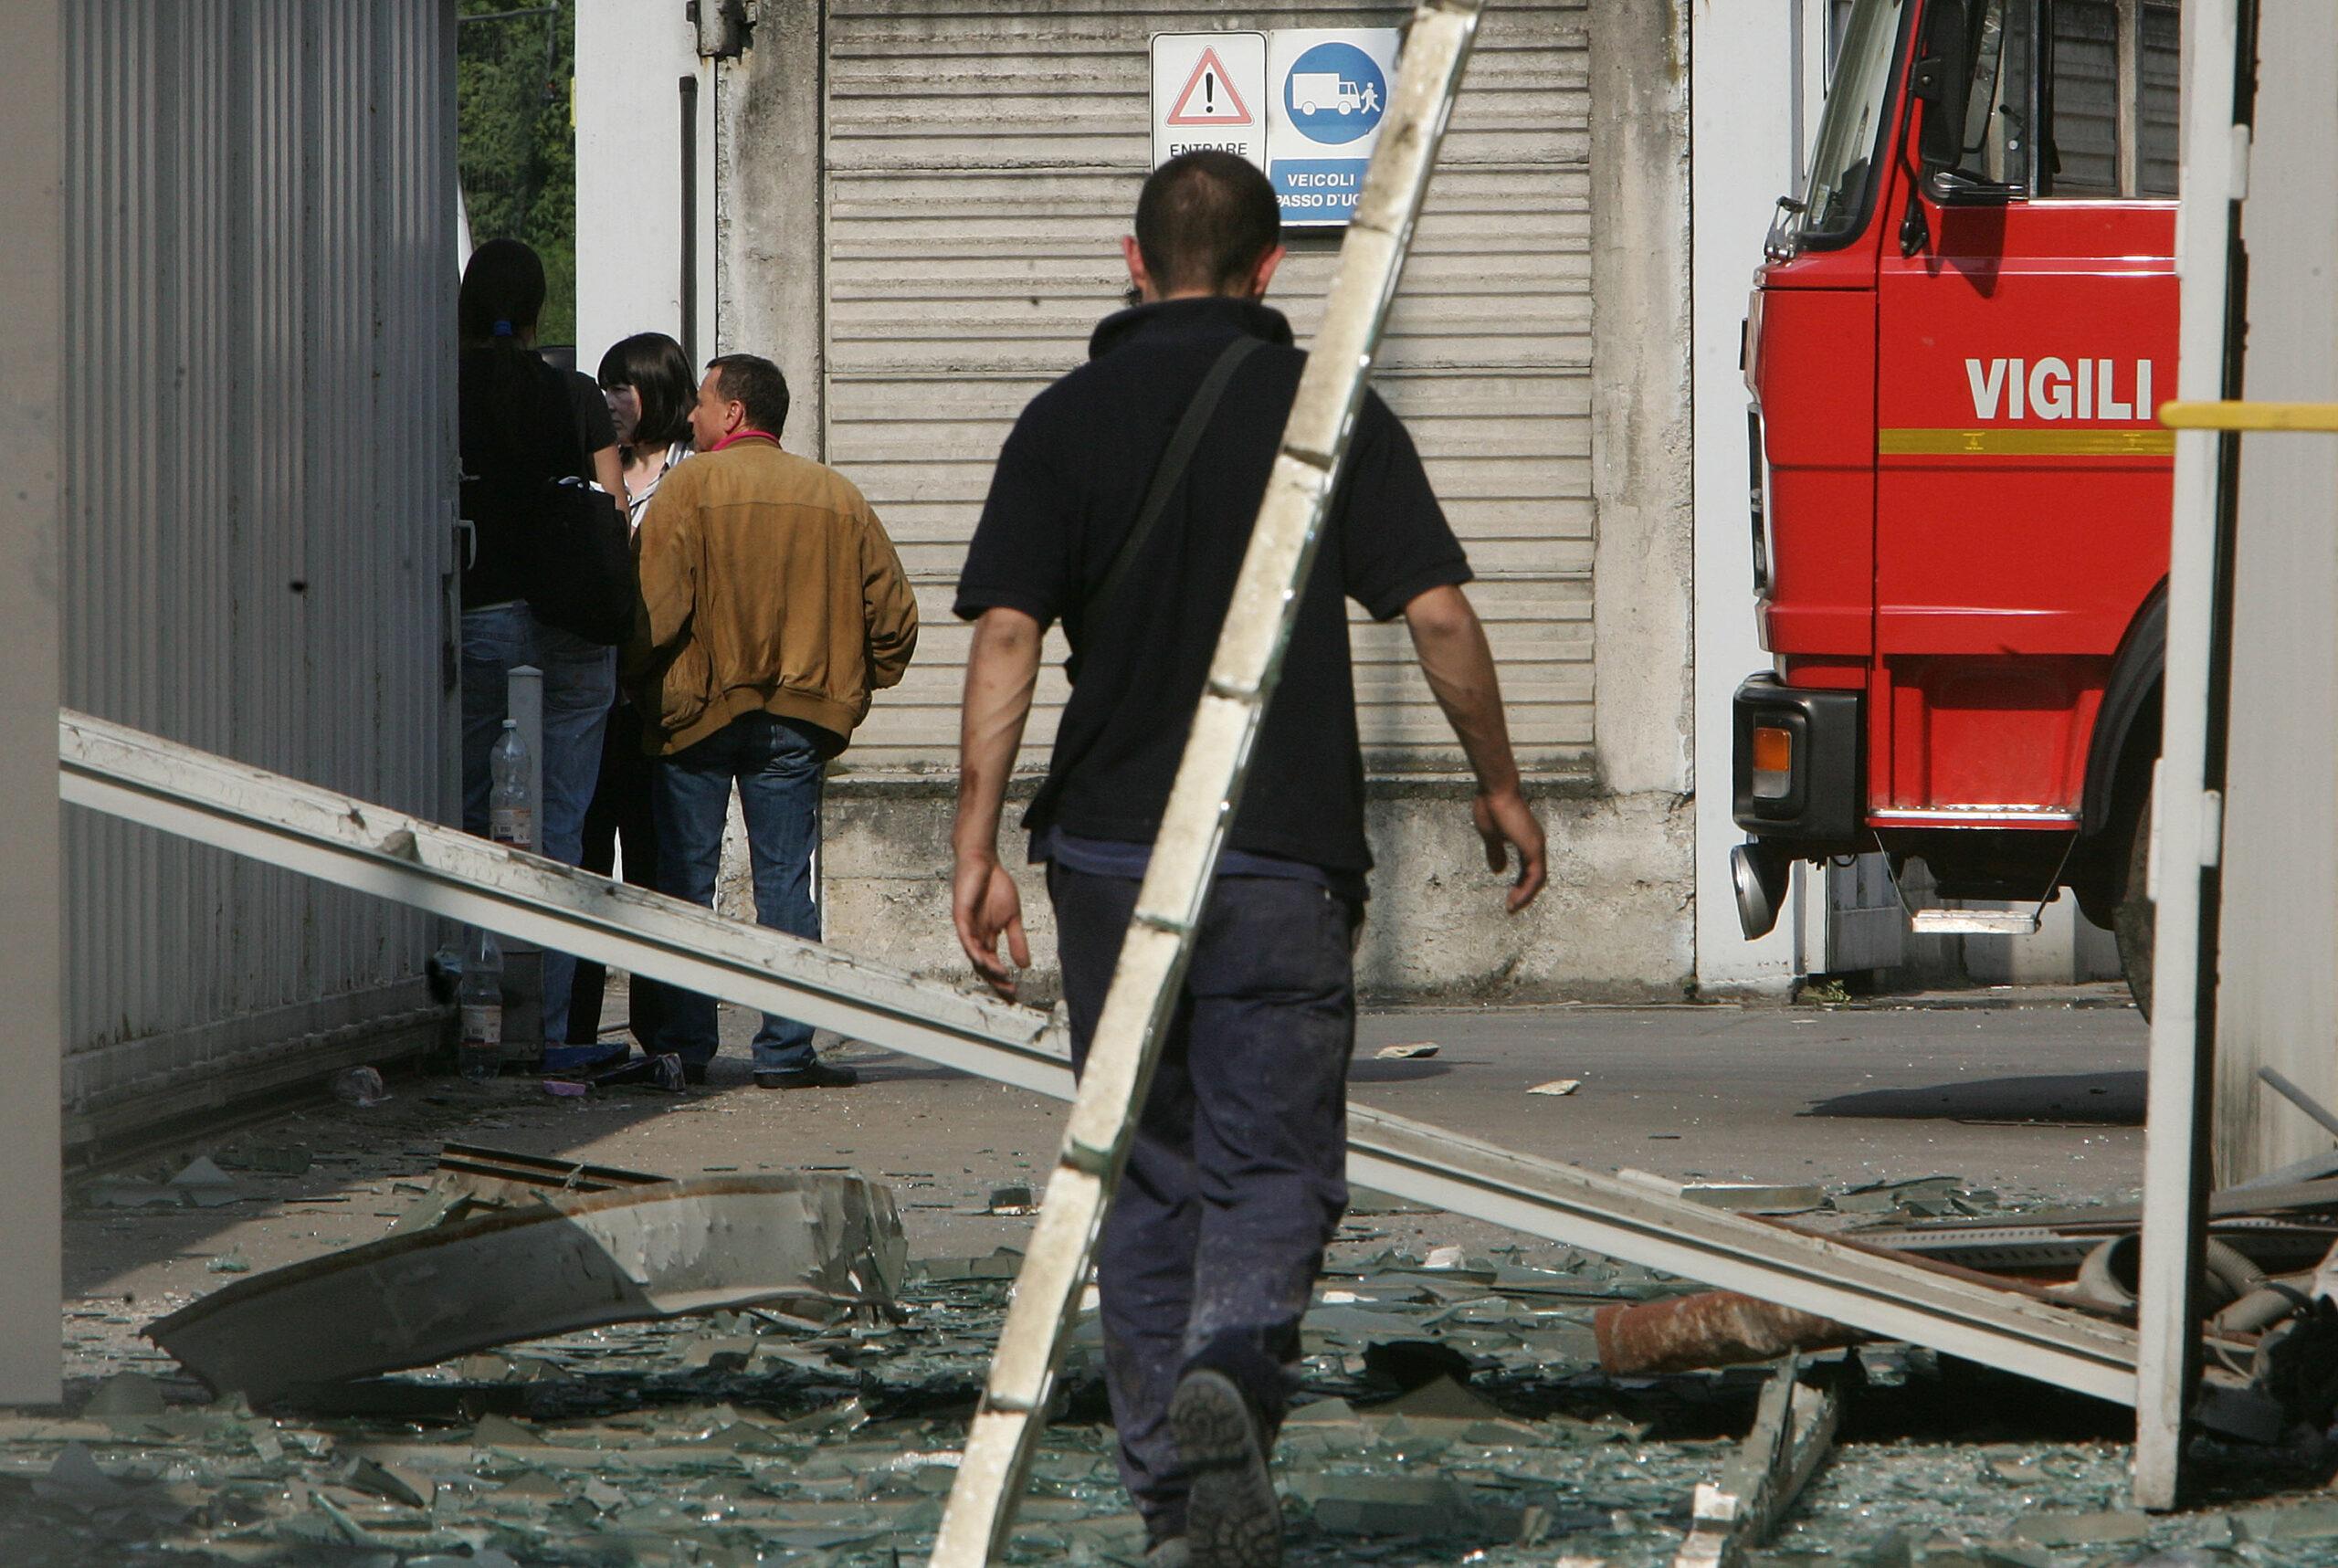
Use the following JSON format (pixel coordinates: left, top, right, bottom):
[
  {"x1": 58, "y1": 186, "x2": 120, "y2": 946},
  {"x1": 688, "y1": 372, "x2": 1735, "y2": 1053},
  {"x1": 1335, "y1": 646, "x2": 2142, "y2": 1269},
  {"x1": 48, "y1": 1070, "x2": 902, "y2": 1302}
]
[{"x1": 1730, "y1": 676, "x2": 1866, "y2": 856}]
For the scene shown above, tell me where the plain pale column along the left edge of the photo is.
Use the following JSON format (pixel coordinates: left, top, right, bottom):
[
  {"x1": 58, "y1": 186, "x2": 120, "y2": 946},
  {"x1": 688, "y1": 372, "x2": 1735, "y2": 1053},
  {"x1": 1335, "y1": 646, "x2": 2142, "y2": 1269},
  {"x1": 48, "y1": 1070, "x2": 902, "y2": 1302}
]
[{"x1": 0, "y1": 0, "x2": 66, "y2": 1405}]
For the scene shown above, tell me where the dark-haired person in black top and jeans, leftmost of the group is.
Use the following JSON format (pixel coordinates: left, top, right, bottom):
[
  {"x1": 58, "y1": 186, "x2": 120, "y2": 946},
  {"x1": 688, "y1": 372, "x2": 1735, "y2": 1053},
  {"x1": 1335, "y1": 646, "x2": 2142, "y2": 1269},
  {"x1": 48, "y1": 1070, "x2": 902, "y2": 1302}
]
[{"x1": 456, "y1": 238, "x2": 625, "y2": 1042}]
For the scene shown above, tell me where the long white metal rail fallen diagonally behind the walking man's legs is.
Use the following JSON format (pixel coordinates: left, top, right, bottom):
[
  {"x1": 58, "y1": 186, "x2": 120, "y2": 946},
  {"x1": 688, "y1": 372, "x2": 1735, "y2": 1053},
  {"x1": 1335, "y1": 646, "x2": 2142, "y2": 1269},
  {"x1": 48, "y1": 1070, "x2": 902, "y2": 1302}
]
[{"x1": 58, "y1": 712, "x2": 2134, "y2": 1405}]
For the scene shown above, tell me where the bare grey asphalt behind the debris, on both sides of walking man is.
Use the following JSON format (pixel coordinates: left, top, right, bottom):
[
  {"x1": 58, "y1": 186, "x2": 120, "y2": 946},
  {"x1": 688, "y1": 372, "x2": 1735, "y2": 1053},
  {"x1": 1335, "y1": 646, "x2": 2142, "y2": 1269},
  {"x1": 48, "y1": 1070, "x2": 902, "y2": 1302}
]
[{"x1": 66, "y1": 994, "x2": 2146, "y2": 1313}]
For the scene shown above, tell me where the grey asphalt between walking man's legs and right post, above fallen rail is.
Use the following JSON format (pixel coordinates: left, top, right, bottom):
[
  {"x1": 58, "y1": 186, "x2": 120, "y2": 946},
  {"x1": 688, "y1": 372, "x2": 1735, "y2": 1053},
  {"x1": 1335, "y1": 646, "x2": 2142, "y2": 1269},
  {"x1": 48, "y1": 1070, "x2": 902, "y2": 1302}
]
[{"x1": 1349, "y1": 1005, "x2": 2149, "y2": 1196}]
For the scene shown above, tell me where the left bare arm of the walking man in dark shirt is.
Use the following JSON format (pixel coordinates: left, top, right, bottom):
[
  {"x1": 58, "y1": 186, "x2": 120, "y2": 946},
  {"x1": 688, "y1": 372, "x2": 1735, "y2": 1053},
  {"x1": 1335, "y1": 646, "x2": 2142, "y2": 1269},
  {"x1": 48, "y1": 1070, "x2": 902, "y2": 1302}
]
[{"x1": 949, "y1": 607, "x2": 1040, "y2": 998}]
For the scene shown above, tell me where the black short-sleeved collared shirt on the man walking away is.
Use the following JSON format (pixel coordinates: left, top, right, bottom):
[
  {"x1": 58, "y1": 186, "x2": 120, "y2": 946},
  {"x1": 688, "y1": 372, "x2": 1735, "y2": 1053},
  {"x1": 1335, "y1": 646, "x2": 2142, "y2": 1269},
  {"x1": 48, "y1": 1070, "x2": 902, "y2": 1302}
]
[{"x1": 956, "y1": 300, "x2": 1470, "y2": 871}]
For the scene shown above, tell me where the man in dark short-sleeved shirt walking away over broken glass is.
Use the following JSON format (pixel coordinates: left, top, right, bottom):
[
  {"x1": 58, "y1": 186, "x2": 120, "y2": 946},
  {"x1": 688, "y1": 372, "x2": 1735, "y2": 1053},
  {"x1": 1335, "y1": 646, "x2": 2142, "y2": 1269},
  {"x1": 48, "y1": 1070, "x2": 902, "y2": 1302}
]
[{"x1": 953, "y1": 152, "x2": 1543, "y2": 1565}]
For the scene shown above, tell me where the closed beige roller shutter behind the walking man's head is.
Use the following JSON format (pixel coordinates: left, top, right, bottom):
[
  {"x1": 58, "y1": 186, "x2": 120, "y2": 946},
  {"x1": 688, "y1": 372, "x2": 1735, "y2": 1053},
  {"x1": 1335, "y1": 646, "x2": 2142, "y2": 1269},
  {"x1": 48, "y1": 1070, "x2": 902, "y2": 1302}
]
[{"x1": 826, "y1": 0, "x2": 1592, "y2": 771}]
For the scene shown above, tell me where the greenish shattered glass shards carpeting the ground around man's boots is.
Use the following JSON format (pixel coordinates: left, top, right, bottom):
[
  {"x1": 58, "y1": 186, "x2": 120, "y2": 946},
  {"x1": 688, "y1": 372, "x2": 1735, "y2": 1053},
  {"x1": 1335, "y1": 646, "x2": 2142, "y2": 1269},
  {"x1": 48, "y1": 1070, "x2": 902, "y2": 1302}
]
[{"x1": 14, "y1": 1247, "x2": 2338, "y2": 1568}]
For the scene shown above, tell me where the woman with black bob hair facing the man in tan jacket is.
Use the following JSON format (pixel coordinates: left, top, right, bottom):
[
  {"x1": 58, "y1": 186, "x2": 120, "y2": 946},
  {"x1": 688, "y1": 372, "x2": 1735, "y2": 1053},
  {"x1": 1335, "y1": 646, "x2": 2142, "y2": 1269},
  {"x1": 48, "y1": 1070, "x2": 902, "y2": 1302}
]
[{"x1": 563, "y1": 331, "x2": 699, "y2": 1070}]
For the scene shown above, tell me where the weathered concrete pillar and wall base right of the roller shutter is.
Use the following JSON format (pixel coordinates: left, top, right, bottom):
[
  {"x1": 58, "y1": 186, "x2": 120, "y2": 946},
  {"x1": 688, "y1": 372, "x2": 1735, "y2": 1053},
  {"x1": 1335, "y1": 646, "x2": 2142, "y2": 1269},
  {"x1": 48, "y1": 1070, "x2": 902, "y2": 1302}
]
[{"x1": 1571, "y1": 0, "x2": 1695, "y2": 995}]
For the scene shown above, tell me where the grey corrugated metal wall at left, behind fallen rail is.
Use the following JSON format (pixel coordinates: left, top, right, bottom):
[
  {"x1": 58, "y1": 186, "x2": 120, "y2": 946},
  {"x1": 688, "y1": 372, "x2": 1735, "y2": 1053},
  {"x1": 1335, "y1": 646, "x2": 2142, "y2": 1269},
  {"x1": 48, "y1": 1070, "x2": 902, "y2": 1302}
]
[{"x1": 61, "y1": 0, "x2": 456, "y2": 1120}]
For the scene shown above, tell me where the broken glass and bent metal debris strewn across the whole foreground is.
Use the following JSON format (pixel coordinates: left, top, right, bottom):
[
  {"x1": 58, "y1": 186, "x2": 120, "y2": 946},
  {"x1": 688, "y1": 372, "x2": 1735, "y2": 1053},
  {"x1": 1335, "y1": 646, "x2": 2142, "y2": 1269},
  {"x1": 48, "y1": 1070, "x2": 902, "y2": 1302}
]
[{"x1": 22, "y1": 1145, "x2": 2338, "y2": 1568}]
